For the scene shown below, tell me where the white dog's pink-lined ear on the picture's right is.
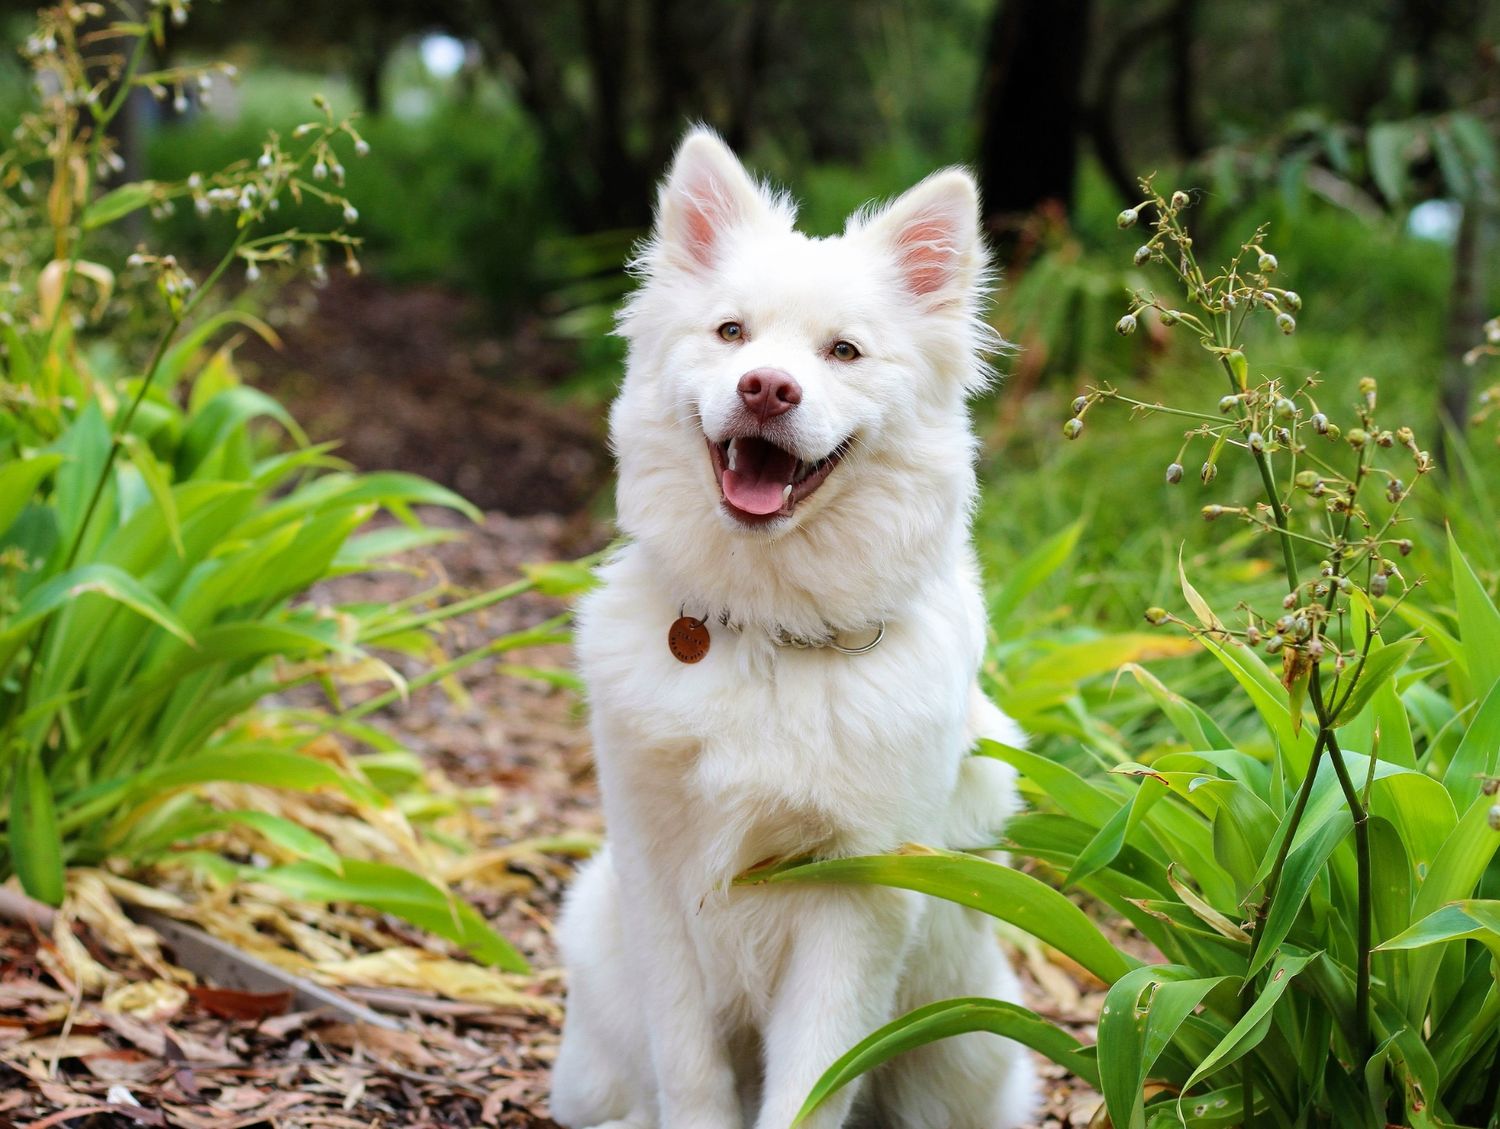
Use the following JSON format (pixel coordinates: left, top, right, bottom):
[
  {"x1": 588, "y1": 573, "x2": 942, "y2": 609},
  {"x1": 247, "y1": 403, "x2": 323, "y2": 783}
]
[{"x1": 864, "y1": 168, "x2": 984, "y2": 304}]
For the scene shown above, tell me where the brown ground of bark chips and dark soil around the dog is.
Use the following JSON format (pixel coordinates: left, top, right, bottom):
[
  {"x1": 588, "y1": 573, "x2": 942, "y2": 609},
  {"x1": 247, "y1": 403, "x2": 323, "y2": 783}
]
[{"x1": 0, "y1": 279, "x2": 1103, "y2": 1129}]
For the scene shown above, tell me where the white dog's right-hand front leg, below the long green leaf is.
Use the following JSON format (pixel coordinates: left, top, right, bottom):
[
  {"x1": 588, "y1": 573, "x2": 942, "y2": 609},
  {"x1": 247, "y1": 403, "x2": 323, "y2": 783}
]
[{"x1": 756, "y1": 888, "x2": 918, "y2": 1129}]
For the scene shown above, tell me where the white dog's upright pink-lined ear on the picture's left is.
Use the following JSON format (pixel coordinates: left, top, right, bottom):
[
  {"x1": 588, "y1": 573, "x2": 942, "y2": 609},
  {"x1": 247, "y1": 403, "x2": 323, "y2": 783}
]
[{"x1": 654, "y1": 127, "x2": 773, "y2": 270}]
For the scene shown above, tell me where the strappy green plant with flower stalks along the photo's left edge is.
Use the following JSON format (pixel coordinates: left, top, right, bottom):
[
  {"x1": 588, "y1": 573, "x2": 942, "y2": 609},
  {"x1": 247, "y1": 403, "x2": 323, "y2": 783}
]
[{"x1": 0, "y1": 6, "x2": 579, "y2": 969}]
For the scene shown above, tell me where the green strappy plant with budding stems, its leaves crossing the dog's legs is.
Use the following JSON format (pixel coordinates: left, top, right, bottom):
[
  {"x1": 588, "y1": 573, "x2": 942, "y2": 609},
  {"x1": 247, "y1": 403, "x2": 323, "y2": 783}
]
[{"x1": 756, "y1": 180, "x2": 1500, "y2": 1129}]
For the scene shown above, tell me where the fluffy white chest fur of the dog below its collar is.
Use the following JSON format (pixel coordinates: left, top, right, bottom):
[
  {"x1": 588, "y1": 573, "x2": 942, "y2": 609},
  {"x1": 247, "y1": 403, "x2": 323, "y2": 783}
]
[{"x1": 579, "y1": 547, "x2": 981, "y2": 898}]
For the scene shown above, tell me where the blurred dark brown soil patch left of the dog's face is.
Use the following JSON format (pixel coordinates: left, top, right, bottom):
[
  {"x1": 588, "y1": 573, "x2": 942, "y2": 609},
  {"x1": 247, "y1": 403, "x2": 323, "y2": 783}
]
[{"x1": 239, "y1": 273, "x2": 609, "y2": 516}]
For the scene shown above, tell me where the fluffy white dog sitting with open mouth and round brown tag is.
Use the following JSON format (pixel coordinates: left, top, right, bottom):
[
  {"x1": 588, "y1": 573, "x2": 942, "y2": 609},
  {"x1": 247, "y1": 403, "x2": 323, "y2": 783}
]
[{"x1": 552, "y1": 130, "x2": 1035, "y2": 1129}]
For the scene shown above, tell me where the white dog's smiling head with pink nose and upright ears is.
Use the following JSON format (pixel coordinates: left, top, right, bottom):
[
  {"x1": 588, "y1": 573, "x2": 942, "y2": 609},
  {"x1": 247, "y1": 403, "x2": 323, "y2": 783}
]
[{"x1": 612, "y1": 129, "x2": 993, "y2": 626}]
